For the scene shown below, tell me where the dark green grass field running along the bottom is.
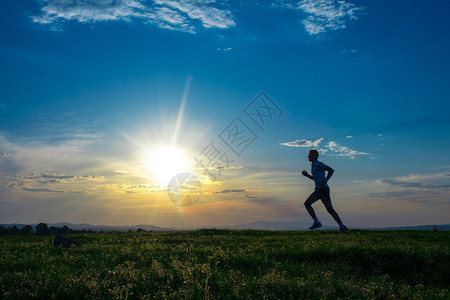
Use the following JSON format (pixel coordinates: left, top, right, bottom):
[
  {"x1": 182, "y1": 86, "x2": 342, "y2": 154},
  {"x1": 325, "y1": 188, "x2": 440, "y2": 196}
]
[{"x1": 0, "y1": 230, "x2": 450, "y2": 299}]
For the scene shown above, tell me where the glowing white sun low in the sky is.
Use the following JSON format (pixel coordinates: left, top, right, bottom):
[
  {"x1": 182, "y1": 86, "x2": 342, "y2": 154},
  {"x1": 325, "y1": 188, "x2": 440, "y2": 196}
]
[{"x1": 146, "y1": 146, "x2": 189, "y2": 186}]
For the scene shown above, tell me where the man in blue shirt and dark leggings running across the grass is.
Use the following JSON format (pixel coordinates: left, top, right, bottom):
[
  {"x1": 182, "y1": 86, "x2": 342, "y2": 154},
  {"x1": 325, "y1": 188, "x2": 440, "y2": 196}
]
[{"x1": 302, "y1": 149, "x2": 348, "y2": 233}]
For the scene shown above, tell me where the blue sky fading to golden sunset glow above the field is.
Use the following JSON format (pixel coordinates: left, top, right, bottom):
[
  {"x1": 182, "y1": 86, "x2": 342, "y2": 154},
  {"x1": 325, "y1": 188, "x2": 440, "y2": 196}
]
[{"x1": 0, "y1": 0, "x2": 450, "y2": 227}]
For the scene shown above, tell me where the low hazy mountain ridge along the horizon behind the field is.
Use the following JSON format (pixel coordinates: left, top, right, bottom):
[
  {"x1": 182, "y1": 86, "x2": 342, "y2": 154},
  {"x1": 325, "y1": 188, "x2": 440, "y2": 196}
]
[{"x1": 0, "y1": 222, "x2": 450, "y2": 232}]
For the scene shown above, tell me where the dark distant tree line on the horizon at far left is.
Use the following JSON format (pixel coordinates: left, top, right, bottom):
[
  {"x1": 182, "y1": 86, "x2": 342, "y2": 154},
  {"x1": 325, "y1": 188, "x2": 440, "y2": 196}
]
[{"x1": 0, "y1": 223, "x2": 96, "y2": 236}]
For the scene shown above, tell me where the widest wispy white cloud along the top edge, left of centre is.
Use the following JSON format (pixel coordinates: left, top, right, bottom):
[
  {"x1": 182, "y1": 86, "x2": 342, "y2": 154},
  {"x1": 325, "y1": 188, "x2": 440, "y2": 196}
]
[{"x1": 32, "y1": 0, "x2": 236, "y2": 33}]
